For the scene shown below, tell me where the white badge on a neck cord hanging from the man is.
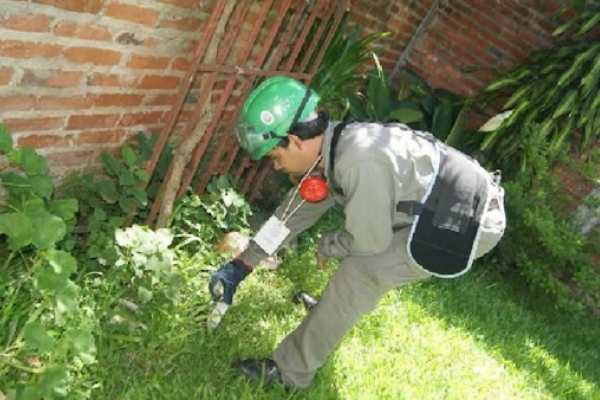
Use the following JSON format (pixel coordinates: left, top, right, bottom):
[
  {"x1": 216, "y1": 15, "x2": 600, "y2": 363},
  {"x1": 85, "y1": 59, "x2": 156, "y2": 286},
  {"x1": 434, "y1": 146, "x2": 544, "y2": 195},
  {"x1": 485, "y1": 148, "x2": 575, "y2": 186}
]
[{"x1": 252, "y1": 155, "x2": 321, "y2": 256}]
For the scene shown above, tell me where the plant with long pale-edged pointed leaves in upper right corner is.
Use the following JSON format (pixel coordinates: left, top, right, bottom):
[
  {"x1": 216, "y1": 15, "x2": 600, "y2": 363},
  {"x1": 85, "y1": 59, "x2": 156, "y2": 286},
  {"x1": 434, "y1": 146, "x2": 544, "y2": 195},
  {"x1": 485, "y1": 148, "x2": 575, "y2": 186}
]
[{"x1": 481, "y1": 1, "x2": 600, "y2": 172}]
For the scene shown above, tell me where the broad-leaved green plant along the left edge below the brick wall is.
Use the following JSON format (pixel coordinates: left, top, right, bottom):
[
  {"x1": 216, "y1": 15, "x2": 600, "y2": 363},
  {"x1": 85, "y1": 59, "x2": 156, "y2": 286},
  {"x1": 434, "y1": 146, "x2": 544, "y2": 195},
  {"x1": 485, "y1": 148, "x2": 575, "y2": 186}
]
[{"x1": 0, "y1": 125, "x2": 96, "y2": 399}]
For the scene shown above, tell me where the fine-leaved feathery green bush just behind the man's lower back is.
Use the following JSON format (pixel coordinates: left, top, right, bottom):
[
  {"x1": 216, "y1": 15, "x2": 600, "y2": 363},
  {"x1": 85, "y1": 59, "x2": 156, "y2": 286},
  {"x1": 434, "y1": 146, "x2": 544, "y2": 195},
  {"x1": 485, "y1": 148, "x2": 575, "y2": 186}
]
[{"x1": 496, "y1": 145, "x2": 600, "y2": 309}]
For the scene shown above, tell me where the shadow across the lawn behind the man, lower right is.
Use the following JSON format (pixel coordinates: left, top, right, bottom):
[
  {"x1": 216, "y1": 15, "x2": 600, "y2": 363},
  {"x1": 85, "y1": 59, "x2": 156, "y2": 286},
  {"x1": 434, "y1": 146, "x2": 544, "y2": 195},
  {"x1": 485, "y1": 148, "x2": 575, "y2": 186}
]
[{"x1": 404, "y1": 264, "x2": 600, "y2": 400}]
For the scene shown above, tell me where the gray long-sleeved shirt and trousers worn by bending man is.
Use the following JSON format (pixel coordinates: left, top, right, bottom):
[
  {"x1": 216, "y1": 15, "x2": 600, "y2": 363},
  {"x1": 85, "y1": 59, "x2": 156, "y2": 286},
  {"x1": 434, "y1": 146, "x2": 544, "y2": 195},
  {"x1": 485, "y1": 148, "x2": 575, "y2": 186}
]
[{"x1": 241, "y1": 123, "x2": 506, "y2": 388}]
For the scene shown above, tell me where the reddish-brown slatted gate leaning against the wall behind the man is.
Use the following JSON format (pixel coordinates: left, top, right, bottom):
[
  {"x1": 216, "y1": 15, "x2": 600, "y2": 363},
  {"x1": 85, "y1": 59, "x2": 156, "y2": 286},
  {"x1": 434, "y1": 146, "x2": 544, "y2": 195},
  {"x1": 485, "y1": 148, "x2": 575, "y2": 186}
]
[{"x1": 146, "y1": 0, "x2": 350, "y2": 227}]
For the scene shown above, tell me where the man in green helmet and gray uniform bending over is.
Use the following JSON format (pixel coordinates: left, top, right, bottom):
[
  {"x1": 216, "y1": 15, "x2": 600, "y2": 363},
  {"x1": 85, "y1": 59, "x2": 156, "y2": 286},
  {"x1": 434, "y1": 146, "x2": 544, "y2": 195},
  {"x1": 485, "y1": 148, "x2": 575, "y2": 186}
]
[{"x1": 209, "y1": 77, "x2": 506, "y2": 388}]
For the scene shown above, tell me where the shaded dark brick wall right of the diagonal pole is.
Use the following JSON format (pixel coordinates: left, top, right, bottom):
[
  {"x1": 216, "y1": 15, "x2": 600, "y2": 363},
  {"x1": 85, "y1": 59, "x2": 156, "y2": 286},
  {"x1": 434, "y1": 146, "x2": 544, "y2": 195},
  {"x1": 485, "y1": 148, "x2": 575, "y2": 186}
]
[{"x1": 407, "y1": 0, "x2": 569, "y2": 96}]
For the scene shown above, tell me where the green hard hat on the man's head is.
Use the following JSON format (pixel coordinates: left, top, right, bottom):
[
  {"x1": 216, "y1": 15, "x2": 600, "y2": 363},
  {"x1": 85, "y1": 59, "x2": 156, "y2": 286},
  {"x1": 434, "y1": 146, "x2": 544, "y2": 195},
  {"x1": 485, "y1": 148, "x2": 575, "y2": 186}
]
[{"x1": 235, "y1": 76, "x2": 320, "y2": 160}]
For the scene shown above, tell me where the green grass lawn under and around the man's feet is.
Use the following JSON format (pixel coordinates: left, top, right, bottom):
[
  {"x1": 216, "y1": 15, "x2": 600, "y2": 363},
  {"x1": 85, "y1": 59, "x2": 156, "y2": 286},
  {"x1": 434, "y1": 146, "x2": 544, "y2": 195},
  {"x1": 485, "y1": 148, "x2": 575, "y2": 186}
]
[{"x1": 91, "y1": 244, "x2": 600, "y2": 400}]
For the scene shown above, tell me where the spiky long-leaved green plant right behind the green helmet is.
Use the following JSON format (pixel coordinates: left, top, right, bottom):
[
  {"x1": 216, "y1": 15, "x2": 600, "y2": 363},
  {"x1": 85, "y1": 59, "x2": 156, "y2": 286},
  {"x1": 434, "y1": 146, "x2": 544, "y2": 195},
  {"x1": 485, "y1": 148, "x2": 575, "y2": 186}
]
[{"x1": 309, "y1": 13, "x2": 389, "y2": 121}]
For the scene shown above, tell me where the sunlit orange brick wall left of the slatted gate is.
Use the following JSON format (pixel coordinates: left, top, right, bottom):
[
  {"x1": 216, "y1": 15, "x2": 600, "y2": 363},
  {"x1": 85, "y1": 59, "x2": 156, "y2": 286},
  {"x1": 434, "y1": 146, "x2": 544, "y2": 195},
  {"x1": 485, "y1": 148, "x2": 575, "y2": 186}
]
[{"x1": 0, "y1": 0, "x2": 212, "y2": 174}]
